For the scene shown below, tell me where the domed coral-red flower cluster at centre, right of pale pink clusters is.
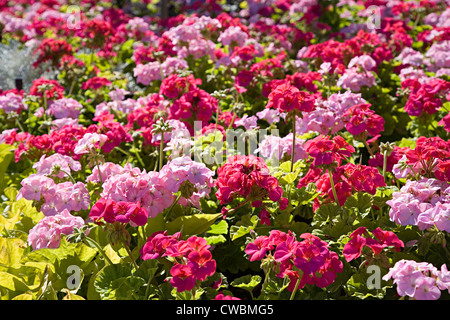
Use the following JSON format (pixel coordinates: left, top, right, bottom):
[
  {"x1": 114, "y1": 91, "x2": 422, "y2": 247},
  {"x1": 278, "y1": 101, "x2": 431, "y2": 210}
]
[{"x1": 215, "y1": 155, "x2": 287, "y2": 220}]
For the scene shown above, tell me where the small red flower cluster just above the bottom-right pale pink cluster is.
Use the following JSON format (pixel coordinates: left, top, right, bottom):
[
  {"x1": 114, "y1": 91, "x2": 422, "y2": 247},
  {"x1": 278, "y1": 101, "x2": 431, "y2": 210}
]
[{"x1": 342, "y1": 227, "x2": 404, "y2": 263}]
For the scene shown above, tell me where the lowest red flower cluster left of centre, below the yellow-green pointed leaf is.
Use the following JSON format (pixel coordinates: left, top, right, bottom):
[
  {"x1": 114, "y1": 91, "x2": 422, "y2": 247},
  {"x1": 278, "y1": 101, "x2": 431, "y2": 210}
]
[{"x1": 140, "y1": 231, "x2": 216, "y2": 292}]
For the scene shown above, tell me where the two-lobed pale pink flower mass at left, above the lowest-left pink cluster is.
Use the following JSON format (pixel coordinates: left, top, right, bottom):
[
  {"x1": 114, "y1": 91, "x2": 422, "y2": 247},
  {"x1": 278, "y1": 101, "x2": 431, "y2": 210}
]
[{"x1": 17, "y1": 174, "x2": 90, "y2": 216}]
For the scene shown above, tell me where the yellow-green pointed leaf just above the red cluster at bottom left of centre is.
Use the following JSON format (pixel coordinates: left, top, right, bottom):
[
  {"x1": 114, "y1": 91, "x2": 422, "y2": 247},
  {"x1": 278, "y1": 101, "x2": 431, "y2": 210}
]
[{"x1": 166, "y1": 213, "x2": 222, "y2": 236}]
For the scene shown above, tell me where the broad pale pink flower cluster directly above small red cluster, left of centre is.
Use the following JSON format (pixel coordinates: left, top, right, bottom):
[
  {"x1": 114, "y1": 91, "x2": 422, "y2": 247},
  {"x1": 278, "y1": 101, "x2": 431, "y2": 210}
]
[{"x1": 101, "y1": 168, "x2": 174, "y2": 217}]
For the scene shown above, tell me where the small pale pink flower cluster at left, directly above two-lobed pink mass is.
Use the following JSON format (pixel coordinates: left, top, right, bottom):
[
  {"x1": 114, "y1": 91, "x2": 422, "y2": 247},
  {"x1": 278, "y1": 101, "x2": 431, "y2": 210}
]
[{"x1": 33, "y1": 153, "x2": 81, "y2": 179}]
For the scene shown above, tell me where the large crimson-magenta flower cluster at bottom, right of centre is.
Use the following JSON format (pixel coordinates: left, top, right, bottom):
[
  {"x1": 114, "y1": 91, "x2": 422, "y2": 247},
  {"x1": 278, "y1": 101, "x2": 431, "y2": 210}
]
[{"x1": 245, "y1": 230, "x2": 343, "y2": 291}]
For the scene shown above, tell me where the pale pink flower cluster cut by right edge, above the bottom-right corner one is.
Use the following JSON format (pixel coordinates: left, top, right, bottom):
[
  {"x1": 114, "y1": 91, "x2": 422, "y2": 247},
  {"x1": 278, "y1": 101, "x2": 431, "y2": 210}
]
[{"x1": 386, "y1": 178, "x2": 450, "y2": 232}]
